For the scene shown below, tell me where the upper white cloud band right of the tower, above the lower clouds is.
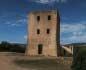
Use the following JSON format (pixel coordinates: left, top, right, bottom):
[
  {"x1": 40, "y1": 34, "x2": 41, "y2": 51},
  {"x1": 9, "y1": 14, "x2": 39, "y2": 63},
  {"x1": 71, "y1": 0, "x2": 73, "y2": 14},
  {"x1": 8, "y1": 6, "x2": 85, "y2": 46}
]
[{"x1": 61, "y1": 22, "x2": 86, "y2": 33}]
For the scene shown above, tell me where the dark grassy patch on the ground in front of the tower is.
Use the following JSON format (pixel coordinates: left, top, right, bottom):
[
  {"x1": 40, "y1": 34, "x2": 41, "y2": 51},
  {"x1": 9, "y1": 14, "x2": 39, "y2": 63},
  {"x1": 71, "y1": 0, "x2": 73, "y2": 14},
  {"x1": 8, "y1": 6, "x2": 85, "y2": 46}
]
[{"x1": 15, "y1": 59, "x2": 70, "y2": 70}]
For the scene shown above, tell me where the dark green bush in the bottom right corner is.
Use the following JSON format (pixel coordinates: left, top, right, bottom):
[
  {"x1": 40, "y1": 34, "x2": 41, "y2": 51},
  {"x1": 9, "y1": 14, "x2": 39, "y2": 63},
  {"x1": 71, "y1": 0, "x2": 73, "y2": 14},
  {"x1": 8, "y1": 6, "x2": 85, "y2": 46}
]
[{"x1": 72, "y1": 46, "x2": 86, "y2": 70}]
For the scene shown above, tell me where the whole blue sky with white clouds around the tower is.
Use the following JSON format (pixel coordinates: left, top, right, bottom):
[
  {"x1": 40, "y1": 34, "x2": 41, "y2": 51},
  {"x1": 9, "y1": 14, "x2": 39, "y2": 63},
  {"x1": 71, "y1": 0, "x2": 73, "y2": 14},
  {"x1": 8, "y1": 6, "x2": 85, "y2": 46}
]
[{"x1": 0, "y1": 0, "x2": 86, "y2": 44}]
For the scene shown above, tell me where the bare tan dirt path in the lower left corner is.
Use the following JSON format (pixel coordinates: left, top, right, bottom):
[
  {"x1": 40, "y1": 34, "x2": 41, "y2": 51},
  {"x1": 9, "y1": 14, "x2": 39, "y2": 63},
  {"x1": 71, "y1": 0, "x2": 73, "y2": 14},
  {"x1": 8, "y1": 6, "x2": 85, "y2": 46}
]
[{"x1": 0, "y1": 53, "x2": 31, "y2": 70}]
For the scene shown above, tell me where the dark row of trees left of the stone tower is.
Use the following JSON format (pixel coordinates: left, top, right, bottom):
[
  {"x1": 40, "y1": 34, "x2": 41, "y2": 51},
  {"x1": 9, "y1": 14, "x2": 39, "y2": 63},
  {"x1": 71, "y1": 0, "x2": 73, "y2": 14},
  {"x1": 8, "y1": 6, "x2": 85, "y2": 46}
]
[{"x1": 0, "y1": 41, "x2": 25, "y2": 53}]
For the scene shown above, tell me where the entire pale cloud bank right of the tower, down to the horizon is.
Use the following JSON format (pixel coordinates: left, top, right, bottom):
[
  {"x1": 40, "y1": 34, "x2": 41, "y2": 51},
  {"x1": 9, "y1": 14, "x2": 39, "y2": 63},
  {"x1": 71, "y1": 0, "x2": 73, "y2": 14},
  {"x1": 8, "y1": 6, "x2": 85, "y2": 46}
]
[{"x1": 61, "y1": 21, "x2": 86, "y2": 44}]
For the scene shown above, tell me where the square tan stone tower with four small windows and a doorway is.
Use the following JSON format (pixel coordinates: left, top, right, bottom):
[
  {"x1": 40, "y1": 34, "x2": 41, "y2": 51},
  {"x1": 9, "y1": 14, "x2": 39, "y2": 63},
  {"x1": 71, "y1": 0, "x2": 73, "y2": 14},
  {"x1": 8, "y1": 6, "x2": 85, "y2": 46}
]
[{"x1": 26, "y1": 10, "x2": 60, "y2": 56}]
